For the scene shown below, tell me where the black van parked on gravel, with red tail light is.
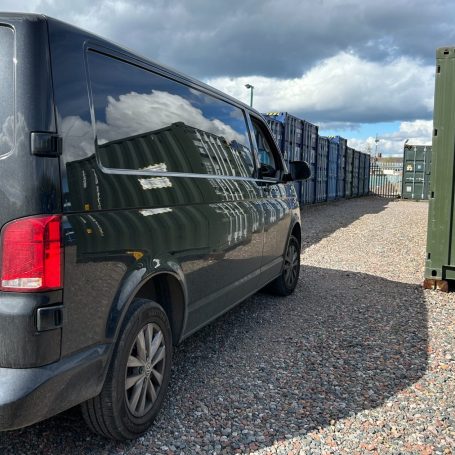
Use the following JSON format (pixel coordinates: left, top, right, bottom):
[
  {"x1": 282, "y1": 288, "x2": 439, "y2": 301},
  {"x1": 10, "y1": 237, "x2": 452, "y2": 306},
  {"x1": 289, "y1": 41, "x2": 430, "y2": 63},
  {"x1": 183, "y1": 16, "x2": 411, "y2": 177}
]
[{"x1": 0, "y1": 13, "x2": 309, "y2": 439}]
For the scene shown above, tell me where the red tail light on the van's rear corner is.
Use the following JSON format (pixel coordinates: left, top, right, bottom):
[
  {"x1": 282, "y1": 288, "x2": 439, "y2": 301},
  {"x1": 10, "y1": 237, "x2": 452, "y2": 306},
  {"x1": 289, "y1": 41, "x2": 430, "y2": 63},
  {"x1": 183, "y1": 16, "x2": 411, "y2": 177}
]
[{"x1": 0, "y1": 215, "x2": 63, "y2": 292}]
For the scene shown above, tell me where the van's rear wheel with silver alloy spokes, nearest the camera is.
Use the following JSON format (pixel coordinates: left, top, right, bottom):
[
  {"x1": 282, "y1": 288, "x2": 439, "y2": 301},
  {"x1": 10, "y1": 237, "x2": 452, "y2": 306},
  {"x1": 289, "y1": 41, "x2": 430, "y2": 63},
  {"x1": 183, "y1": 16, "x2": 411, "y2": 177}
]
[{"x1": 81, "y1": 299, "x2": 172, "y2": 440}]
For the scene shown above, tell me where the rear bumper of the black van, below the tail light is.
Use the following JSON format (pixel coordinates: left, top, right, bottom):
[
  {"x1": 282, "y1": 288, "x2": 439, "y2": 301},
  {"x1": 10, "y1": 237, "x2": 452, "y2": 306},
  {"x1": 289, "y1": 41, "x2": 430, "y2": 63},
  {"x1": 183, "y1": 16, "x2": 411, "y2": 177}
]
[{"x1": 0, "y1": 344, "x2": 111, "y2": 430}]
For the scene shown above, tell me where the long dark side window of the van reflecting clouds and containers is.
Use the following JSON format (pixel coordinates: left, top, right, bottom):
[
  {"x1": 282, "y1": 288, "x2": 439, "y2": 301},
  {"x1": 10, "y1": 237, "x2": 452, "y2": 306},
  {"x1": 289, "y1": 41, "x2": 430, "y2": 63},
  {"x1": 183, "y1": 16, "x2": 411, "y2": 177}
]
[{"x1": 88, "y1": 51, "x2": 255, "y2": 177}]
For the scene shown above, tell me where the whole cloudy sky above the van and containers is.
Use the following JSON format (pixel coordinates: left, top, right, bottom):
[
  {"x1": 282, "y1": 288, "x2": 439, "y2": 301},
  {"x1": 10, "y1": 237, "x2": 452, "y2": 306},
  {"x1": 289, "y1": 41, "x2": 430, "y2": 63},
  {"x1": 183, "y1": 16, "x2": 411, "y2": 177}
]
[{"x1": 0, "y1": 0, "x2": 455, "y2": 156}]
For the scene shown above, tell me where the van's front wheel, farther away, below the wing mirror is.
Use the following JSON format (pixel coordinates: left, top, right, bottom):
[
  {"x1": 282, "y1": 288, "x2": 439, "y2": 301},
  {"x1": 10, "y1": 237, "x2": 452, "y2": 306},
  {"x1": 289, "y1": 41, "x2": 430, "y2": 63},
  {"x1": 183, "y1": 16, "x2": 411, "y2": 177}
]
[{"x1": 266, "y1": 235, "x2": 300, "y2": 296}]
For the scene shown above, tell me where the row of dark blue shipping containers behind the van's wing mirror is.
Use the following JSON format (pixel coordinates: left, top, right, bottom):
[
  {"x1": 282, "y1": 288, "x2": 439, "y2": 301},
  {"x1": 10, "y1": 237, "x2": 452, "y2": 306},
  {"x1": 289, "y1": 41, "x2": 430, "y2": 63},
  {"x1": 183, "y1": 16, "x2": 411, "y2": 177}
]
[{"x1": 264, "y1": 112, "x2": 370, "y2": 205}]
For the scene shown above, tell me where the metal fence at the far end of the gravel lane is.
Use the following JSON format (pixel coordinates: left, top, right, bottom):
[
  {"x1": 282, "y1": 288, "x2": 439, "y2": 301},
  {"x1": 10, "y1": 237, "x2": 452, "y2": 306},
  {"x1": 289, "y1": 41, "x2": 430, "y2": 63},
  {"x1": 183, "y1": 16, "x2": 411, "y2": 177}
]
[{"x1": 370, "y1": 163, "x2": 403, "y2": 198}]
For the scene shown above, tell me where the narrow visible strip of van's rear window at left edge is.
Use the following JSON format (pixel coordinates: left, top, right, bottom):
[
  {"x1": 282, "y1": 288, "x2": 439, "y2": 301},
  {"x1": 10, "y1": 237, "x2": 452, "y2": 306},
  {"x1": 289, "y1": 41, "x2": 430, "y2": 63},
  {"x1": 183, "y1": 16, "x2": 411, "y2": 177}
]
[{"x1": 0, "y1": 25, "x2": 15, "y2": 156}]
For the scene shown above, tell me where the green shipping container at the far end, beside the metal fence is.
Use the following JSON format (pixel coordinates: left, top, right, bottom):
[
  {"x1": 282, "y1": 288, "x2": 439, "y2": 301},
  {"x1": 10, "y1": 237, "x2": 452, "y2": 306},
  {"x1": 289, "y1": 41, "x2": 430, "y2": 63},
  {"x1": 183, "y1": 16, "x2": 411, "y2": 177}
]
[{"x1": 401, "y1": 144, "x2": 432, "y2": 201}]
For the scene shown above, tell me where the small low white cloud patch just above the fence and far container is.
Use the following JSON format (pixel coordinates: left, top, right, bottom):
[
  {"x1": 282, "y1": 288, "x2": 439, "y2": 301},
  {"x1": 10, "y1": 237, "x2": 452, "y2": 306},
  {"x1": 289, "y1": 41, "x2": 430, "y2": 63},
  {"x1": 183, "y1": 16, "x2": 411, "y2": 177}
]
[{"x1": 348, "y1": 120, "x2": 433, "y2": 156}]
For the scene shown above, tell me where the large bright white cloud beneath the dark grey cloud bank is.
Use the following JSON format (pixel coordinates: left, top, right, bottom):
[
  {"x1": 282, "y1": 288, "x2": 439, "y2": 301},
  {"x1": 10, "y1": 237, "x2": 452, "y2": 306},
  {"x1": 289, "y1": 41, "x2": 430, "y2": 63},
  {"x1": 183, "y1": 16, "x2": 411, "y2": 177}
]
[{"x1": 208, "y1": 52, "x2": 434, "y2": 123}]
